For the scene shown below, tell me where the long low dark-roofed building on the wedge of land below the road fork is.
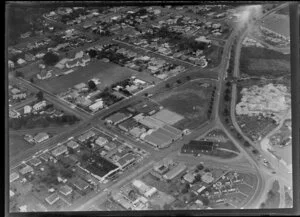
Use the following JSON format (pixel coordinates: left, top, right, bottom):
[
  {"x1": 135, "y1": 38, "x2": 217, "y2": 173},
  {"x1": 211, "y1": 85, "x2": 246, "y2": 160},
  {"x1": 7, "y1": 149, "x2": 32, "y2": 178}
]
[{"x1": 181, "y1": 140, "x2": 214, "y2": 154}]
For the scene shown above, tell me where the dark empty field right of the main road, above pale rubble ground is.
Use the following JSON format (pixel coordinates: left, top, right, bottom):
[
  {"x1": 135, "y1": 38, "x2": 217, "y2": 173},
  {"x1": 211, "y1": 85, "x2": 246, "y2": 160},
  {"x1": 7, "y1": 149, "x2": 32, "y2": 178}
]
[{"x1": 240, "y1": 47, "x2": 290, "y2": 77}]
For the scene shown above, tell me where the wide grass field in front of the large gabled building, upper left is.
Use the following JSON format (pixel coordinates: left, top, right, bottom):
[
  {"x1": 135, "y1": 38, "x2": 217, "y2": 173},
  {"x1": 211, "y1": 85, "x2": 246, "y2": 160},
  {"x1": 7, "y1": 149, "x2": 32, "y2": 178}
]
[{"x1": 36, "y1": 61, "x2": 159, "y2": 94}]
